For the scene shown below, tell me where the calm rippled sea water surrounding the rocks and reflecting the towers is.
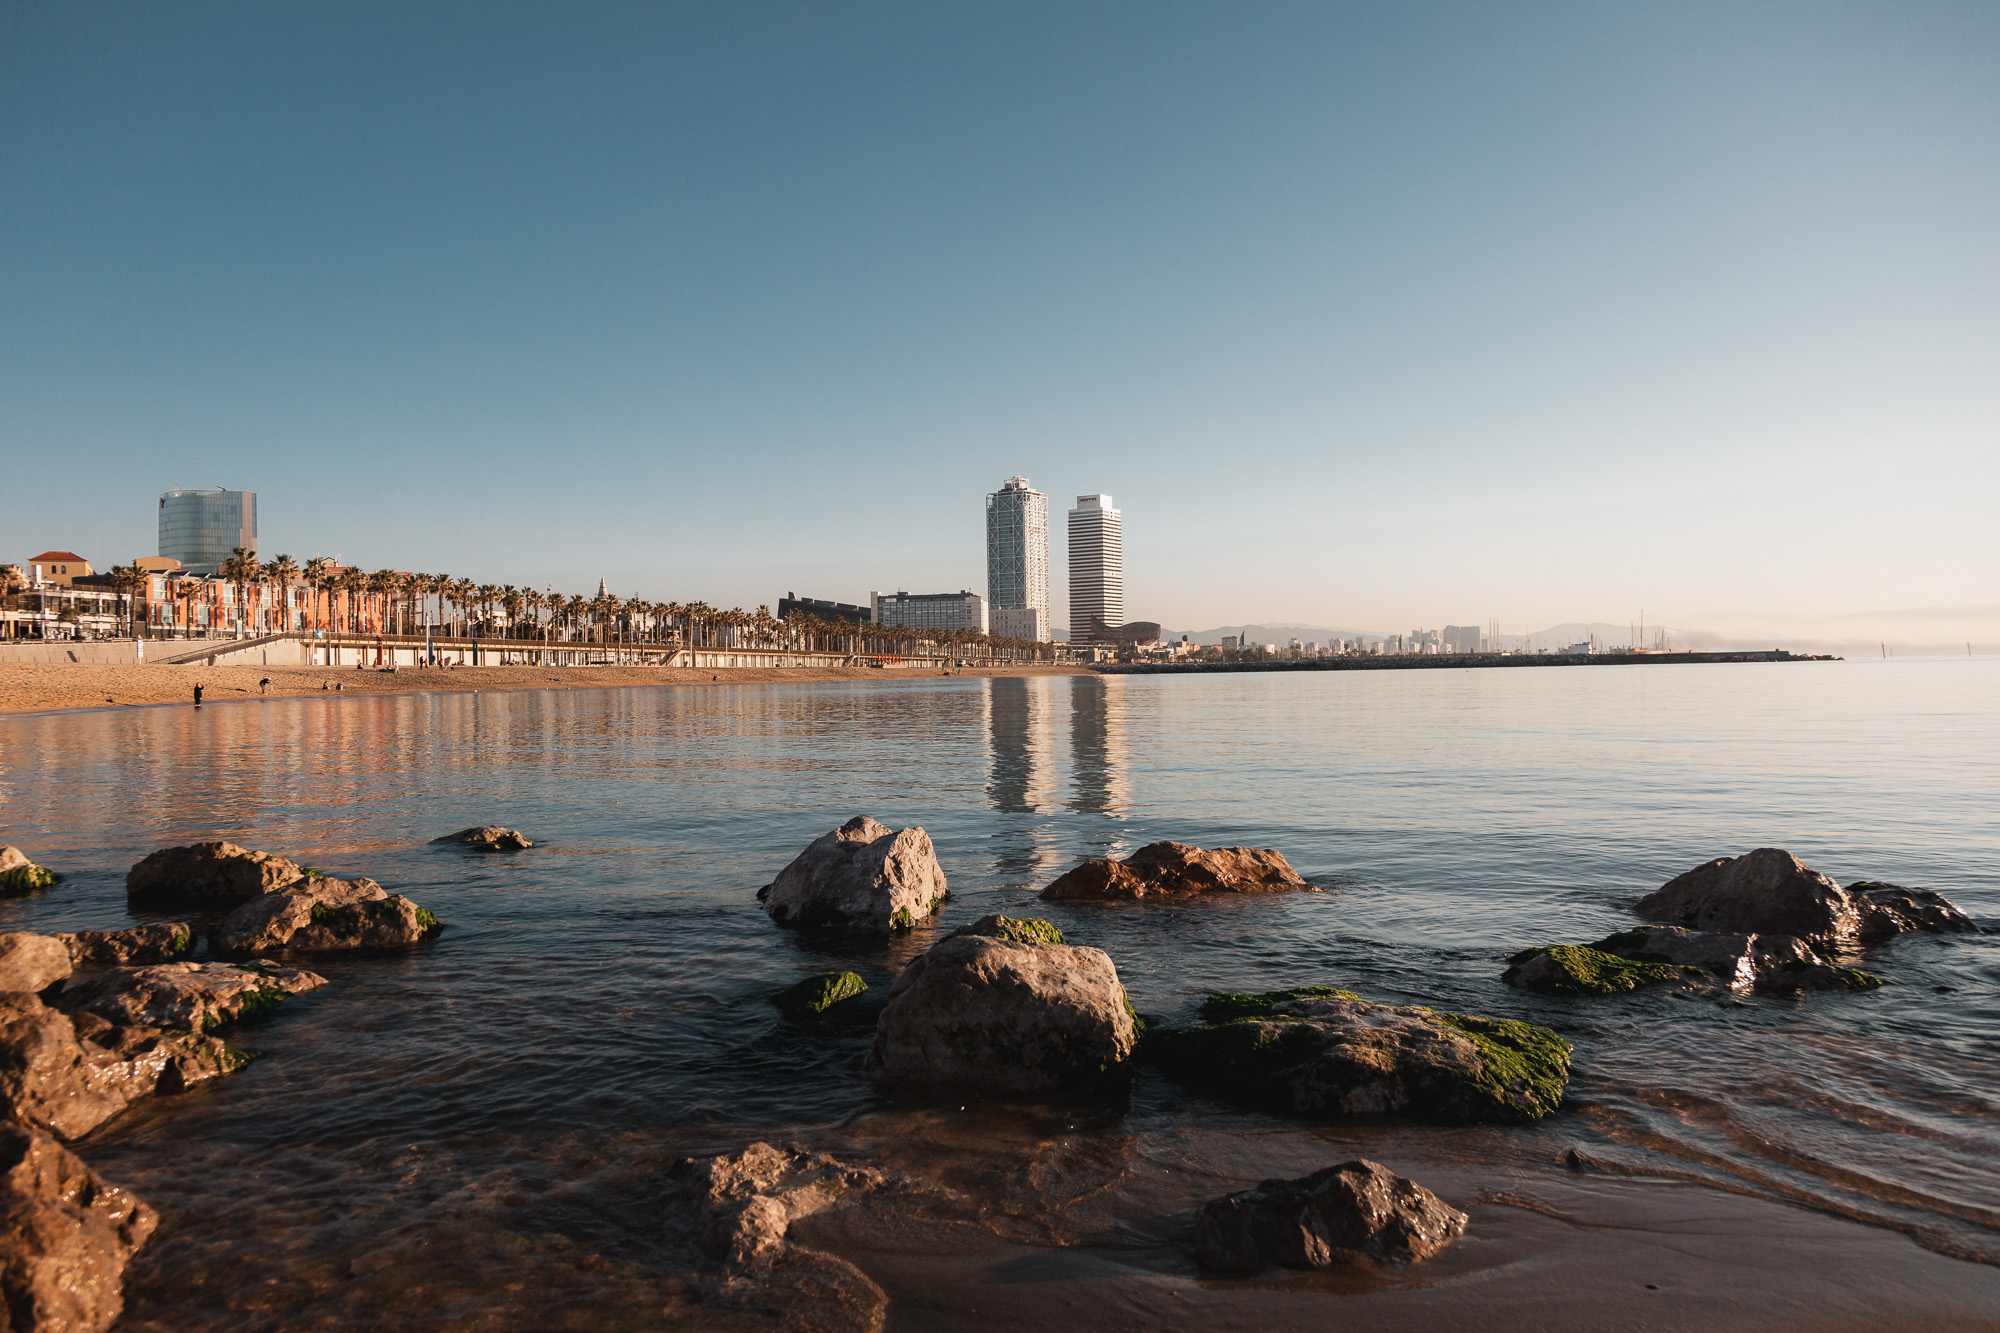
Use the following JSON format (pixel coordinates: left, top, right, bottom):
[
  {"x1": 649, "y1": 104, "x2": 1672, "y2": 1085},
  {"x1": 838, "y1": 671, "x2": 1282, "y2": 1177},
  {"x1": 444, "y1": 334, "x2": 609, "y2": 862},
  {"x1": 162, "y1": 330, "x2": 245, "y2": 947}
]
[{"x1": 0, "y1": 658, "x2": 2000, "y2": 1329}]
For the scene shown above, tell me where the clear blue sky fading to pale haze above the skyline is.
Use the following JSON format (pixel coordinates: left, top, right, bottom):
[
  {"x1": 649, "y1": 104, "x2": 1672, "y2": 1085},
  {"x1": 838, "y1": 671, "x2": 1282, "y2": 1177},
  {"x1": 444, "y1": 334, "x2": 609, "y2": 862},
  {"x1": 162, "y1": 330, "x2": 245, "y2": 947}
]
[{"x1": 0, "y1": 0, "x2": 2000, "y2": 638}]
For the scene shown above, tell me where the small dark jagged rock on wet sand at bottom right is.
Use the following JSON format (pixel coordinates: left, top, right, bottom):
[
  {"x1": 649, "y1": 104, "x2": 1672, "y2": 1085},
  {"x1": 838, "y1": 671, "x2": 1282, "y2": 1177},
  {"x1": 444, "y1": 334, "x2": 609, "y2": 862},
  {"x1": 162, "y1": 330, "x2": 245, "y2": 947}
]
[{"x1": 1194, "y1": 1159, "x2": 1466, "y2": 1273}]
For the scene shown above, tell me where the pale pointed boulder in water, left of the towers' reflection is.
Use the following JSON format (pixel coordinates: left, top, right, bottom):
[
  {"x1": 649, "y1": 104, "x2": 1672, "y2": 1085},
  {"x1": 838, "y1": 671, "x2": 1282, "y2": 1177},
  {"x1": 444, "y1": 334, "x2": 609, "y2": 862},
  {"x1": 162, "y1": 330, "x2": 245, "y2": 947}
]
[{"x1": 756, "y1": 815, "x2": 946, "y2": 933}]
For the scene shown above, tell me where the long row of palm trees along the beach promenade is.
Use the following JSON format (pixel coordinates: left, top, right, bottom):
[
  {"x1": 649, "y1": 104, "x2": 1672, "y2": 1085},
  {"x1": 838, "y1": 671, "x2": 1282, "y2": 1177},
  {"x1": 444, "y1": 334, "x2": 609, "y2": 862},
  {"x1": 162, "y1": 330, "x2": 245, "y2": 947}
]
[{"x1": 146, "y1": 546, "x2": 1054, "y2": 660}]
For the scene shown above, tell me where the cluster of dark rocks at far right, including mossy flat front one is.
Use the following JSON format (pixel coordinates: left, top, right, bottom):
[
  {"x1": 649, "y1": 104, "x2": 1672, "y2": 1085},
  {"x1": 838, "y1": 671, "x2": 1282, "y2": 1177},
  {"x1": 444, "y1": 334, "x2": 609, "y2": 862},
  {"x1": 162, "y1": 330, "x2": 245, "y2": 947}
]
[{"x1": 1502, "y1": 847, "x2": 1974, "y2": 995}]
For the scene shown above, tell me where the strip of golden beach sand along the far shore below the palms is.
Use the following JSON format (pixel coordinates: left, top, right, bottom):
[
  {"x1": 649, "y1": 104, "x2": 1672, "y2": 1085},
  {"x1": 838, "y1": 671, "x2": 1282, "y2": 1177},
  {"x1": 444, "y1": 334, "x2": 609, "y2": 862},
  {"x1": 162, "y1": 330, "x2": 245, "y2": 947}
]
[{"x1": 0, "y1": 662, "x2": 1090, "y2": 713}]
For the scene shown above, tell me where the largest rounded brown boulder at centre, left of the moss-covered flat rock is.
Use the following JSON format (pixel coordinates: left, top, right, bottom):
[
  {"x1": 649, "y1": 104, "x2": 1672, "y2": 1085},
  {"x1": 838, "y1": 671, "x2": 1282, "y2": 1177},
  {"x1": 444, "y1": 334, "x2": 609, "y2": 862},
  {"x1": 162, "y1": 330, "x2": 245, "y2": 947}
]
[{"x1": 868, "y1": 917, "x2": 1138, "y2": 1093}]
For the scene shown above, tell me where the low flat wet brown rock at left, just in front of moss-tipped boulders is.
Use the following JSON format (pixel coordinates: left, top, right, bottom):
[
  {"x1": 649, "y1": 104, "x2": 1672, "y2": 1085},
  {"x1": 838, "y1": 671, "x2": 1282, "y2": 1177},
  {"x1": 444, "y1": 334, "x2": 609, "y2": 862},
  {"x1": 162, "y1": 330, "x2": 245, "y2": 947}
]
[{"x1": 56, "y1": 963, "x2": 326, "y2": 1033}]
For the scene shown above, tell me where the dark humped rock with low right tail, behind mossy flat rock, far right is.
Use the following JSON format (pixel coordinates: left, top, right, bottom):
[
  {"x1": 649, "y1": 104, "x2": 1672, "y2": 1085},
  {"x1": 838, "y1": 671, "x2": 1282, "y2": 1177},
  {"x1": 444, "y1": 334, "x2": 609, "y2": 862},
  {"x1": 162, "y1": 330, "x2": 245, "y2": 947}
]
[{"x1": 1634, "y1": 847, "x2": 1974, "y2": 947}]
